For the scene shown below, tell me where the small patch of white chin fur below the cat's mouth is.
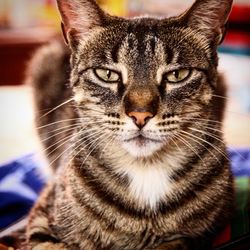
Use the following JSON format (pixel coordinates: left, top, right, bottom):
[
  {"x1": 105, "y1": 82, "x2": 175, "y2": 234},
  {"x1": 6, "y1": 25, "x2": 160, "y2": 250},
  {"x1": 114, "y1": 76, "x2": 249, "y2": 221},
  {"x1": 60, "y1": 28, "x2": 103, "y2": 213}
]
[{"x1": 122, "y1": 140, "x2": 162, "y2": 157}]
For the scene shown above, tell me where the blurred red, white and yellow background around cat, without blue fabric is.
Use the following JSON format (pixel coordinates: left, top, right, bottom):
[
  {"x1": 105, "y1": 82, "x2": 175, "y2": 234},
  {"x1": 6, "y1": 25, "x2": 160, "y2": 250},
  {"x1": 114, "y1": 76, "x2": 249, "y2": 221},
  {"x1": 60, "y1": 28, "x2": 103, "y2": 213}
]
[{"x1": 0, "y1": 0, "x2": 250, "y2": 164}]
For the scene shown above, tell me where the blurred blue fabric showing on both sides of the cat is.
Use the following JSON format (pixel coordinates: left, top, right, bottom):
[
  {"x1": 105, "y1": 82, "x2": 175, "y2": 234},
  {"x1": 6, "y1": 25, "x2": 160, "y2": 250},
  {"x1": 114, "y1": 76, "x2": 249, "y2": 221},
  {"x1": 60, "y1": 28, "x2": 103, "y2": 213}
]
[{"x1": 0, "y1": 149, "x2": 250, "y2": 230}]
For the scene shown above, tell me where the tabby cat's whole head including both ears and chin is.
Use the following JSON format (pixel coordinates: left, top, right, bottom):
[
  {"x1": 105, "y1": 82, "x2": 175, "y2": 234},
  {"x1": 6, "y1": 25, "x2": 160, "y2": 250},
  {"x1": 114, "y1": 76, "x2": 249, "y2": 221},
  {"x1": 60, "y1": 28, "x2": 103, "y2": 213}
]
[{"x1": 58, "y1": 0, "x2": 232, "y2": 157}]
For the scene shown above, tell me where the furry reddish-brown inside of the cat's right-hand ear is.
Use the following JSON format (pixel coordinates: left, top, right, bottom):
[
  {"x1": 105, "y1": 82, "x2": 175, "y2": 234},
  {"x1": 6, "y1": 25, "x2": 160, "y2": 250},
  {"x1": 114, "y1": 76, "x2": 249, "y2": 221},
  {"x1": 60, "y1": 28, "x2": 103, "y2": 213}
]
[{"x1": 182, "y1": 0, "x2": 233, "y2": 44}]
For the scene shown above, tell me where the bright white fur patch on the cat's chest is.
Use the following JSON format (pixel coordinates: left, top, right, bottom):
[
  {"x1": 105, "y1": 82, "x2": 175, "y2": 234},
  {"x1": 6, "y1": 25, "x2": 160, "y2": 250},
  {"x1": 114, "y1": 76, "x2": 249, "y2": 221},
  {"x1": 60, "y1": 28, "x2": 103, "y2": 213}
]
[{"x1": 113, "y1": 156, "x2": 182, "y2": 209}]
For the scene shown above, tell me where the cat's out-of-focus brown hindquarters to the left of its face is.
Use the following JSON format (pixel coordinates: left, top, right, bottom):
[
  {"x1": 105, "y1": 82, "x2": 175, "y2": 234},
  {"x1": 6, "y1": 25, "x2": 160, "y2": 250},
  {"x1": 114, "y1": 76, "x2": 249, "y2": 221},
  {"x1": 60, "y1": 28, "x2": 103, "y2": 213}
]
[{"x1": 26, "y1": 39, "x2": 75, "y2": 168}]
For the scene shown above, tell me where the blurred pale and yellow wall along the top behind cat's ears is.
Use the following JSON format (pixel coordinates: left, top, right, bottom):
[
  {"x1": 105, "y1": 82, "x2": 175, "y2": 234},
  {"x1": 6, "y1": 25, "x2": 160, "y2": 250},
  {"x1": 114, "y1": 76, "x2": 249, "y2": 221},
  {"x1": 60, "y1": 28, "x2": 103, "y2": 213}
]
[{"x1": 0, "y1": 0, "x2": 250, "y2": 28}]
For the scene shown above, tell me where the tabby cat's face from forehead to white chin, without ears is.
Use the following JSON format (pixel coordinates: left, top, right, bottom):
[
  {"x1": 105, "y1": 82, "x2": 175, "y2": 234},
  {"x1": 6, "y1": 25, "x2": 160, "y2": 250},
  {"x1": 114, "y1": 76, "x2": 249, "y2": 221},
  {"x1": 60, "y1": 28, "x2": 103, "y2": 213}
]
[{"x1": 73, "y1": 19, "x2": 215, "y2": 157}]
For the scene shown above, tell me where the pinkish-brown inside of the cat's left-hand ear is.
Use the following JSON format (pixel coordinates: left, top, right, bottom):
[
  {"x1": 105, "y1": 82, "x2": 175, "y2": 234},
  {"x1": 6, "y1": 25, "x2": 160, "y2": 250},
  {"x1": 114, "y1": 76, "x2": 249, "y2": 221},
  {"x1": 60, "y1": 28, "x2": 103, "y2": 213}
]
[{"x1": 57, "y1": 0, "x2": 106, "y2": 43}]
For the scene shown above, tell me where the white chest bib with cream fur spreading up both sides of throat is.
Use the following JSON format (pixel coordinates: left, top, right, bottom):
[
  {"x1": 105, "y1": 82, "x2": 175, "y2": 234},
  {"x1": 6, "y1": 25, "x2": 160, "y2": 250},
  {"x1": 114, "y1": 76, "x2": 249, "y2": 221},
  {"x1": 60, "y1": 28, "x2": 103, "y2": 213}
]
[{"x1": 107, "y1": 148, "x2": 185, "y2": 209}]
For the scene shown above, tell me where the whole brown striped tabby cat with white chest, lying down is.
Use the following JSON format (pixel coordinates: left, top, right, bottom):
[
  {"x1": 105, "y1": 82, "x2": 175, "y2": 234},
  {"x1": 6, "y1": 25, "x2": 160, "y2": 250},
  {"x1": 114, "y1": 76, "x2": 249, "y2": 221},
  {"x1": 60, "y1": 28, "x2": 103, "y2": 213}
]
[{"x1": 27, "y1": 0, "x2": 233, "y2": 250}]
